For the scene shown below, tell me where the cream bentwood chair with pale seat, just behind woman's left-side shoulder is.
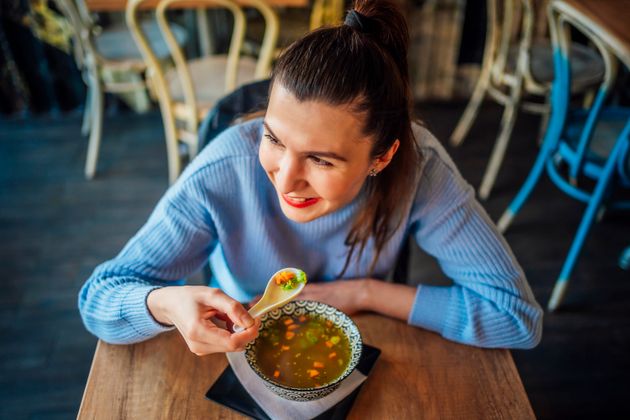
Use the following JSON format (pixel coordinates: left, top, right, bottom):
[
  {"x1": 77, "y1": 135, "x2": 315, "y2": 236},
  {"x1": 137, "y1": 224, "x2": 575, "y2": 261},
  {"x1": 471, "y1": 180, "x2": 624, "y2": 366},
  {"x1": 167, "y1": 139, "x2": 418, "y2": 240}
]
[{"x1": 126, "y1": 0, "x2": 278, "y2": 183}]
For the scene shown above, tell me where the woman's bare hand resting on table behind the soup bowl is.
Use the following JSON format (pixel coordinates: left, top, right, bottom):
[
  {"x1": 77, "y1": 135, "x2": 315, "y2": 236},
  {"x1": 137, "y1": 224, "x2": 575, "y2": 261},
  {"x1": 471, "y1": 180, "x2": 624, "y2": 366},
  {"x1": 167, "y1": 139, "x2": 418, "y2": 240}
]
[{"x1": 297, "y1": 279, "x2": 368, "y2": 315}]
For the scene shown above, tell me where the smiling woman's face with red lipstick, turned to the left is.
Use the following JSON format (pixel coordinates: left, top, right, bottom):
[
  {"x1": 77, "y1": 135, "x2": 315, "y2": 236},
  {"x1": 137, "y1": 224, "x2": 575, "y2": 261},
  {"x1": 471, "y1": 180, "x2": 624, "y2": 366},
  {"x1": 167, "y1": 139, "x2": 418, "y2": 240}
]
[{"x1": 259, "y1": 83, "x2": 397, "y2": 223}]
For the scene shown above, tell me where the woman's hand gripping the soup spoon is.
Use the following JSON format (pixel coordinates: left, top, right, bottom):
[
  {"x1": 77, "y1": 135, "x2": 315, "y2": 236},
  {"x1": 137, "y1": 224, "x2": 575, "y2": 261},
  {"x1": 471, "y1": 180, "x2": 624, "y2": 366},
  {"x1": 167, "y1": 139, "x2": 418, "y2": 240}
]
[{"x1": 147, "y1": 286, "x2": 260, "y2": 356}]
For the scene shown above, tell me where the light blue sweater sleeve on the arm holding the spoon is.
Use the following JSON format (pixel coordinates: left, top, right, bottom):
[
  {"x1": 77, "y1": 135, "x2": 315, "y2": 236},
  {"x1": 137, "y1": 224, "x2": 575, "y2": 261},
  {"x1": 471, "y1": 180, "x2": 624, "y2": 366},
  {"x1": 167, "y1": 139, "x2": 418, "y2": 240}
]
[{"x1": 79, "y1": 177, "x2": 217, "y2": 344}]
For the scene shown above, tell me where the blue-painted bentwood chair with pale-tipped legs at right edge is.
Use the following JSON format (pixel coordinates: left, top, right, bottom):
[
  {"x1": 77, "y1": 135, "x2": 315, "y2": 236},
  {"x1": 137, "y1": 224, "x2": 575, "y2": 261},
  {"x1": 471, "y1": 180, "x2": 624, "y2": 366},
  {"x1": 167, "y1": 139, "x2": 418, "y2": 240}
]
[{"x1": 498, "y1": 3, "x2": 630, "y2": 311}]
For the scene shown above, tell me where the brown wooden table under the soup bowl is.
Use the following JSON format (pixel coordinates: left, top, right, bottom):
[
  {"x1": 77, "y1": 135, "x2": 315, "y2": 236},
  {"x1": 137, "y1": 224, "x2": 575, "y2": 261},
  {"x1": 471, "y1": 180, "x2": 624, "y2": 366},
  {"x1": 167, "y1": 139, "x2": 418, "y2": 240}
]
[{"x1": 78, "y1": 314, "x2": 535, "y2": 419}]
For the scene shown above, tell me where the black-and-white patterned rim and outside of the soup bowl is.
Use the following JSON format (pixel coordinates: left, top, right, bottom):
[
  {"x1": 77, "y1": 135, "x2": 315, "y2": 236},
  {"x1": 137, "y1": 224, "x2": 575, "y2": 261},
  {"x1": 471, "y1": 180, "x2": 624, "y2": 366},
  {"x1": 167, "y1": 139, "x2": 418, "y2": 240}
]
[{"x1": 245, "y1": 300, "x2": 363, "y2": 401}]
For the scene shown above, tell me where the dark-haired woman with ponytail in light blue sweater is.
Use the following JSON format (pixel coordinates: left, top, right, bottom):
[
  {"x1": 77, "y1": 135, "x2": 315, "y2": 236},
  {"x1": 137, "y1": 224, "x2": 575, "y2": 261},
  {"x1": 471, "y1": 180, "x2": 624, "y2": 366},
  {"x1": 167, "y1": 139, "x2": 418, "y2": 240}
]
[{"x1": 79, "y1": 0, "x2": 542, "y2": 355}]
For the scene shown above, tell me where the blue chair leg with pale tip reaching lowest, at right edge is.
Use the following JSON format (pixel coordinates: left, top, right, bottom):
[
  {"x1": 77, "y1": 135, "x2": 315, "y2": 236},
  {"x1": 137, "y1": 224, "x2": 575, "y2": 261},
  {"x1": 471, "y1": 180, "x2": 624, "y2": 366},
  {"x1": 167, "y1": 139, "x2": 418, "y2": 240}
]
[{"x1": 547, "y1": 128, "x2": 630, "y2": 312}]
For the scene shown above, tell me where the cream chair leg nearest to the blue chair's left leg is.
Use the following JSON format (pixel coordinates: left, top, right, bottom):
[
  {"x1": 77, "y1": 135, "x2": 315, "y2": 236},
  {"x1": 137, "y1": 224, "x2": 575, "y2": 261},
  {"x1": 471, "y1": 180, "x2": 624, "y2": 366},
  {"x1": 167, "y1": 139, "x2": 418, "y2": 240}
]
[{"x1": 479, "y1": 82, "x2": 521, "y2": 200}]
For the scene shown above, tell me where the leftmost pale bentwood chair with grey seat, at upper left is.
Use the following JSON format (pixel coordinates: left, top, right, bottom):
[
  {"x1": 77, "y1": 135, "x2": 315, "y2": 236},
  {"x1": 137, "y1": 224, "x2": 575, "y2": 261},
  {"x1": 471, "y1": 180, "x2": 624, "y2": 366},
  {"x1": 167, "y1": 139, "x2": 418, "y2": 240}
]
[{"x1": 55, "y1": 0, "x2": 186, "y2": 179}]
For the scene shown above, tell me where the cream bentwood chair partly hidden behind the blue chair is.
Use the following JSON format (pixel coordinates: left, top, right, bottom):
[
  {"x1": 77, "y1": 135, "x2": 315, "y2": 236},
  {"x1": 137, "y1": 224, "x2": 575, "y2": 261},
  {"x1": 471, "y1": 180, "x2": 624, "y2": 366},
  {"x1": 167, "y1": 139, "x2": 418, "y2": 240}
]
[{"x1": 450, "y1": 0, "x2": 604, "y2": 199}]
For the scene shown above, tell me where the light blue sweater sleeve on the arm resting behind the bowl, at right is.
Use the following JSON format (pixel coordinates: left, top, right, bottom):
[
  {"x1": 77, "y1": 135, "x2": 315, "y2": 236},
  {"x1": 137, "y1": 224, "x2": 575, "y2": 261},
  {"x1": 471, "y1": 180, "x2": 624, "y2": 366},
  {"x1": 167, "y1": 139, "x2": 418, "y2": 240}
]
[{"x1": 408, "y1": 141, "x2": 542, "y2": 348}]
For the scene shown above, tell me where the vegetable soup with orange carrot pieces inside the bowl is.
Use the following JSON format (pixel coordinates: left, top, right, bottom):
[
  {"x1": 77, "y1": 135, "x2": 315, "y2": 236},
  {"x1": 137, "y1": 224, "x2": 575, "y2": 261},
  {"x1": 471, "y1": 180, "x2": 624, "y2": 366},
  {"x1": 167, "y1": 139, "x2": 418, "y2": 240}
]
[{"x1": 256, "y1": 315, "x2": 350, "y2": 388}]
